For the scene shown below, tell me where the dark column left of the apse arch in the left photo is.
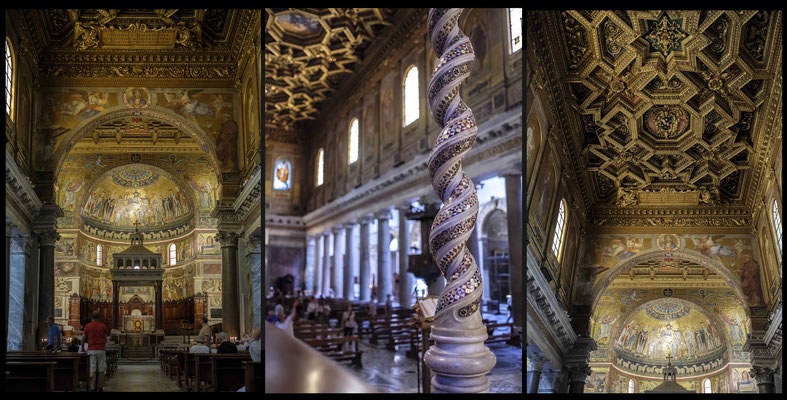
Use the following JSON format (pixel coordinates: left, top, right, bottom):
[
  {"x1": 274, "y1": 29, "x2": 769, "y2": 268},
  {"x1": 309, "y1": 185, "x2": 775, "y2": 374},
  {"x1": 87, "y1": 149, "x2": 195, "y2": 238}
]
[{"x1": 38, "y1": 230, "x2": 60, "y2": 342}]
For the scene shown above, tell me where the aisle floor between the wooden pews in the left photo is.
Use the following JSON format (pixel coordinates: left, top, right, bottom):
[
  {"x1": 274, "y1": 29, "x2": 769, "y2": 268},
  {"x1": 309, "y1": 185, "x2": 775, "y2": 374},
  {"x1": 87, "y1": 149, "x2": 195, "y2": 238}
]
[{"x1": 104, "y1": 360, "x2": 182, "y2": 392}]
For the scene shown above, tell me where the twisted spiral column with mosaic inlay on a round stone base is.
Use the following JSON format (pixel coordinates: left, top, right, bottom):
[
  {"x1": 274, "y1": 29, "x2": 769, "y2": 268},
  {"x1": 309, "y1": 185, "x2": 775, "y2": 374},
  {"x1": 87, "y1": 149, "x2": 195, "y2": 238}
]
[{"x1": 424, "y1": 8, "x2": 496, "y2": 393}]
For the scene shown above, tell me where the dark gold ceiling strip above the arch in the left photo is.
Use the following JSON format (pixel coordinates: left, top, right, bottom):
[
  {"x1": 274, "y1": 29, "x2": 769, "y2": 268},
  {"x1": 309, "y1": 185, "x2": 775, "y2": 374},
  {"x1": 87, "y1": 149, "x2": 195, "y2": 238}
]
[{"x1": 9, "y1": 9, "x2": 260, "y2": 87}]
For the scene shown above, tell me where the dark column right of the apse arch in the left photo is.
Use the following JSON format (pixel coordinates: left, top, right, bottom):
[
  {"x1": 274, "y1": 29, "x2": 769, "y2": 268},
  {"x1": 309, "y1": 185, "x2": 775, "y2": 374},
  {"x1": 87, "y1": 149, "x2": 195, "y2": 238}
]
[{"x1": 216, "y1": 230, "x2": 240, "y2": 337}]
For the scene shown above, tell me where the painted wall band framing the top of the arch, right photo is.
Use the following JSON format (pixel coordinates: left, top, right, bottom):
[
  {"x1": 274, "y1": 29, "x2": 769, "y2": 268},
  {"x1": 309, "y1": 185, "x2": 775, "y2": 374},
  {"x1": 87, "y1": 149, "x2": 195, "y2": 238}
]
[{"x1": 576, "y1": 234, "x2": 763, "y2": 305}]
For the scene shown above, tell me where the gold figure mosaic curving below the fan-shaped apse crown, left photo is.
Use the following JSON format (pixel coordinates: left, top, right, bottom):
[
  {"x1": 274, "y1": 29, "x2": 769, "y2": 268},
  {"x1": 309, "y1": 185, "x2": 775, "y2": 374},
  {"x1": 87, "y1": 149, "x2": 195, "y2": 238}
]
[{"x1": 82, "y1": 176, "x2": 192, "y2": 229}]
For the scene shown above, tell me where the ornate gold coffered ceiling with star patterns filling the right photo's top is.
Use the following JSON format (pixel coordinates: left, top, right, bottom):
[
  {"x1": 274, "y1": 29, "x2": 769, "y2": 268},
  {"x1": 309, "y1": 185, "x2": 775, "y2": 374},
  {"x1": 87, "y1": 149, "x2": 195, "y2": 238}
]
[{"x1": 528, "y1": 11, "x2": 782, "y2": 225}]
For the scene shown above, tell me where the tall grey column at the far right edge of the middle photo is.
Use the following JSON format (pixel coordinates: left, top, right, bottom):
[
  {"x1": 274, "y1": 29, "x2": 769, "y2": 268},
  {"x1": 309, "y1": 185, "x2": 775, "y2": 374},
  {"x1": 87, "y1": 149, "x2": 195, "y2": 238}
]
[{"x1": 503, "y1": 172, "x2": 525, "y2": 333}]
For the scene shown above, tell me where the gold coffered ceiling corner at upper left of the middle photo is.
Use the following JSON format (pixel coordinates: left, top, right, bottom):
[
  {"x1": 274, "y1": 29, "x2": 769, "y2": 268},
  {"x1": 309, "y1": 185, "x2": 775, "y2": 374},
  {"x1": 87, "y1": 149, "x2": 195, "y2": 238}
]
[{"x1": 265, "y1": 8, "x2": 393, "y2": 126}]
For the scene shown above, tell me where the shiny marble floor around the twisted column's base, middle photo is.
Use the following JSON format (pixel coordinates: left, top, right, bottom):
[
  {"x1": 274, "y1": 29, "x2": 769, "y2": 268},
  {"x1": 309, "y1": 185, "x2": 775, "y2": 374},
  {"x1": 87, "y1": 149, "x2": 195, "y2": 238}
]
[{"x1": 343, "y1": 313, "x2": 522, "y2": 393}]
